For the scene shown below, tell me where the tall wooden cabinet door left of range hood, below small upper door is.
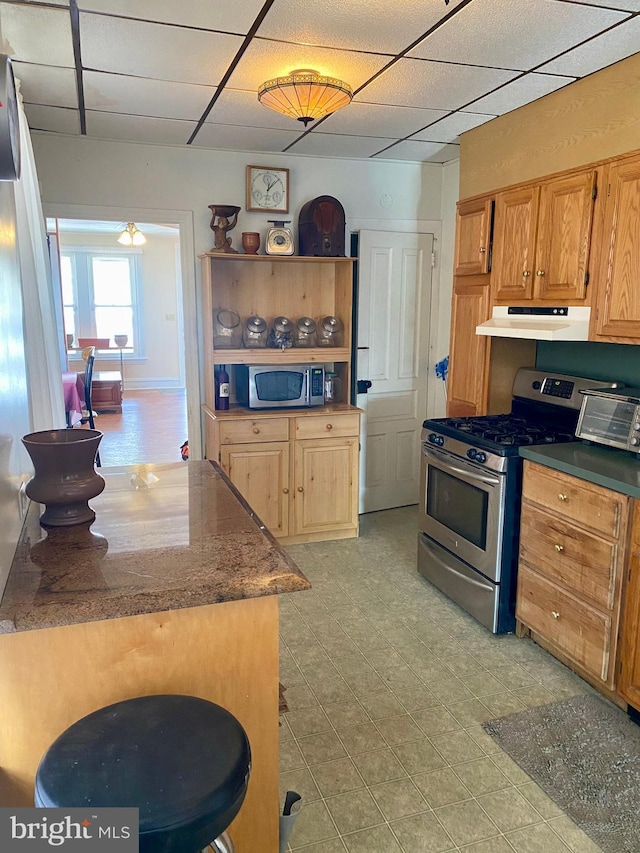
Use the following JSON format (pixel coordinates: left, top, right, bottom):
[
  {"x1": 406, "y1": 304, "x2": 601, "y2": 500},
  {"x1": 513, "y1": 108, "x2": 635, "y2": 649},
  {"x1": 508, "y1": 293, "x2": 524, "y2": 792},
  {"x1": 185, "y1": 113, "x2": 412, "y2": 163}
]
[{"x1": 447, "y1": 281, "x2": 490, "y2": 417}]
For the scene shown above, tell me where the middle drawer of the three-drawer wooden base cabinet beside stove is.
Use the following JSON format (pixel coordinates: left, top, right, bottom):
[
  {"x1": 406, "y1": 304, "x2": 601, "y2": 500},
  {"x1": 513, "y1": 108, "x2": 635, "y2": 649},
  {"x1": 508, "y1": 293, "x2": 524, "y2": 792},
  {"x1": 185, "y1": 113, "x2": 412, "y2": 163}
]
[{"x1": 520, "y1": 501, "x2": 620, "y2": 610}]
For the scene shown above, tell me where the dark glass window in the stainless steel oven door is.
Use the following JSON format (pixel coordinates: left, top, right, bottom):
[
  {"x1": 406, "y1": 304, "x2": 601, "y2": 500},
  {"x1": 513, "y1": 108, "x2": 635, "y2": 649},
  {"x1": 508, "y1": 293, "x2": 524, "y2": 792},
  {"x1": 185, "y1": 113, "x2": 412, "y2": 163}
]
[{"x1": 426, "y1": 466, "x2": 489, "y2": 551}]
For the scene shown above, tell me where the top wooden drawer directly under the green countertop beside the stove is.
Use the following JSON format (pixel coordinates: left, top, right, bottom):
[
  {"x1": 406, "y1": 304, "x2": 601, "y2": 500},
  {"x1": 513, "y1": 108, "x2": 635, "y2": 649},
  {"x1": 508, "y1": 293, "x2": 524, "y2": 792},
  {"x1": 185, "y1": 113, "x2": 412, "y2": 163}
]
[{"x1": 522, "y1": 460, "x2": 629, "y2": 539}]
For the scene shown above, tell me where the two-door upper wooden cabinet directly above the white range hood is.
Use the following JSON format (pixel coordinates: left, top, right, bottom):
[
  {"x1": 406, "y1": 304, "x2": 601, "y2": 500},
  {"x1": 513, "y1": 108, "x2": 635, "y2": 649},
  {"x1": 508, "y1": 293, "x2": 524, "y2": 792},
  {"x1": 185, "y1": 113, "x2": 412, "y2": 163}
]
[{"x1": 491, "y1": 169, "x2": 597, "y2": 305}]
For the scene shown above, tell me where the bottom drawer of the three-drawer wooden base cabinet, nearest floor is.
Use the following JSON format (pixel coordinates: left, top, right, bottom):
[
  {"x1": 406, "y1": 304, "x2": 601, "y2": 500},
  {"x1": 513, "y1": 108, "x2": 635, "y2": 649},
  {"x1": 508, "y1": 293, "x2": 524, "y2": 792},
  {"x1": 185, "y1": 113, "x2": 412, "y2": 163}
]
[{"x1": 516, "y1": 565, "x2": 614, "y2": 686}]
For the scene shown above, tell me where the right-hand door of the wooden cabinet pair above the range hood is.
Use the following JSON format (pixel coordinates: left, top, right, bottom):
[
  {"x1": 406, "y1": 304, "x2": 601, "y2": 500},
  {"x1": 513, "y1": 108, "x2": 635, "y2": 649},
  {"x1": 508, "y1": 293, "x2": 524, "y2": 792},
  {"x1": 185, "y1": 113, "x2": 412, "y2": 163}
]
[{"x1": 534, "y1": 171, "x2": 596, "y2": 303}]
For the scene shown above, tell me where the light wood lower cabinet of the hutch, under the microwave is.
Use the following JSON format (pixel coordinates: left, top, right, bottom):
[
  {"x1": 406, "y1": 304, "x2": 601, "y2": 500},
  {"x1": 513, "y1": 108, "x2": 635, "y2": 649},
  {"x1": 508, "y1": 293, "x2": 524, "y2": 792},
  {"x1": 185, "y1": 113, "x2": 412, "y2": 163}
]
[{"x1": 210, "y1": 404, "x2": 360, "y2": 544}]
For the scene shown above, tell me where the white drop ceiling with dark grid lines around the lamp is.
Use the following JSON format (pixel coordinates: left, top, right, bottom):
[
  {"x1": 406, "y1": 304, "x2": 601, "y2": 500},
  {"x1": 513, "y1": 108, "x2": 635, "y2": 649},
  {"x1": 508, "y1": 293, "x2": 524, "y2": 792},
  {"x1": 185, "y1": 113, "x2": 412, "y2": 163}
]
[{"x1": 6, "y1": 0, "x2": 640, "y2": 163}]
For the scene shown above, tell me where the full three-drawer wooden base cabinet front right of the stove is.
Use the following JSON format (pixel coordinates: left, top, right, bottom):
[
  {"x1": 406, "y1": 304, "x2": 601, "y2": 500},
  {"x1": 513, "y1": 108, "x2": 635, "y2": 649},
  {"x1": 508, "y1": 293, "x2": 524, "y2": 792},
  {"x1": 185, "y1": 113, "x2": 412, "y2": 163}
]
[{"x1": 516, "y1": 461, "x2": 630, "y2": 691}]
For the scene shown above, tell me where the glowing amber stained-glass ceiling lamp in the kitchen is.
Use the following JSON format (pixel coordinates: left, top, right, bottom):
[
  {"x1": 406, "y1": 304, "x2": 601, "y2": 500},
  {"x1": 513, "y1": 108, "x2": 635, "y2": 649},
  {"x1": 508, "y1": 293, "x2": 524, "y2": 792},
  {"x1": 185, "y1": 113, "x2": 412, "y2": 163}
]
[{"x1": 258, "y1": 68, "x2": 353, "y2": 127}]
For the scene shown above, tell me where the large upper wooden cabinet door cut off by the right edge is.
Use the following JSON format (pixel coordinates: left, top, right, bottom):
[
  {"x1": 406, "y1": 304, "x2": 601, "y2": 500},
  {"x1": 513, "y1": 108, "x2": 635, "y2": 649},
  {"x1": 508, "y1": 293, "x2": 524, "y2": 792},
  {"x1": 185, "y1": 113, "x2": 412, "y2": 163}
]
[{"x1": 595, "y1": 157, "x2": 640, "y2": 343}]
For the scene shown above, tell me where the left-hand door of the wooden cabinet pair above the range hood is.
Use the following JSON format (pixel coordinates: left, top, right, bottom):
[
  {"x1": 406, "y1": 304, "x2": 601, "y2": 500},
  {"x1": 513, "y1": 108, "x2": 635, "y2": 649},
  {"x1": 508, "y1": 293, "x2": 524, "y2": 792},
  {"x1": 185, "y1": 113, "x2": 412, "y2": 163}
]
[{"x1": 491, "y1": 187, "x2": 540, "y2": 305}]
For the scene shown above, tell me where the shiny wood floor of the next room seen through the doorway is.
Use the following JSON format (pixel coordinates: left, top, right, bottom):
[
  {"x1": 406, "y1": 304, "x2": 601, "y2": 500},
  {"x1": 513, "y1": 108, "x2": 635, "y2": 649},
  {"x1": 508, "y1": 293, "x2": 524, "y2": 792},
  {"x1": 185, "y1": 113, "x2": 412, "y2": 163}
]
[{"x1": 88, "y1": 390, "x2": 187, "y2": 466}]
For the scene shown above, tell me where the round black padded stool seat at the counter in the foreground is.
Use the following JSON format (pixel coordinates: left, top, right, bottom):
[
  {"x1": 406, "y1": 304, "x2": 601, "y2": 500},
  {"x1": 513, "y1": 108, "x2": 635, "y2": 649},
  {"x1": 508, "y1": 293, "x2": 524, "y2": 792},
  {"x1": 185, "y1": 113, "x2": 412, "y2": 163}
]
[{"x1": 35, "y1": 695, "x2": 251, "y2": 853}]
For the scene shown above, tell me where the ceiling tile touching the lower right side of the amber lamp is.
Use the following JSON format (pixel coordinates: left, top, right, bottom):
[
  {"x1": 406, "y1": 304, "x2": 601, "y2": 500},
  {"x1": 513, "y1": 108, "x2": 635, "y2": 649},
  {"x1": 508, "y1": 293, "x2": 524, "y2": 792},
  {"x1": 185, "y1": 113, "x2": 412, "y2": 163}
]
[{"x1": 322, "y1": 101, "x2": 447, "y2": 139}]
